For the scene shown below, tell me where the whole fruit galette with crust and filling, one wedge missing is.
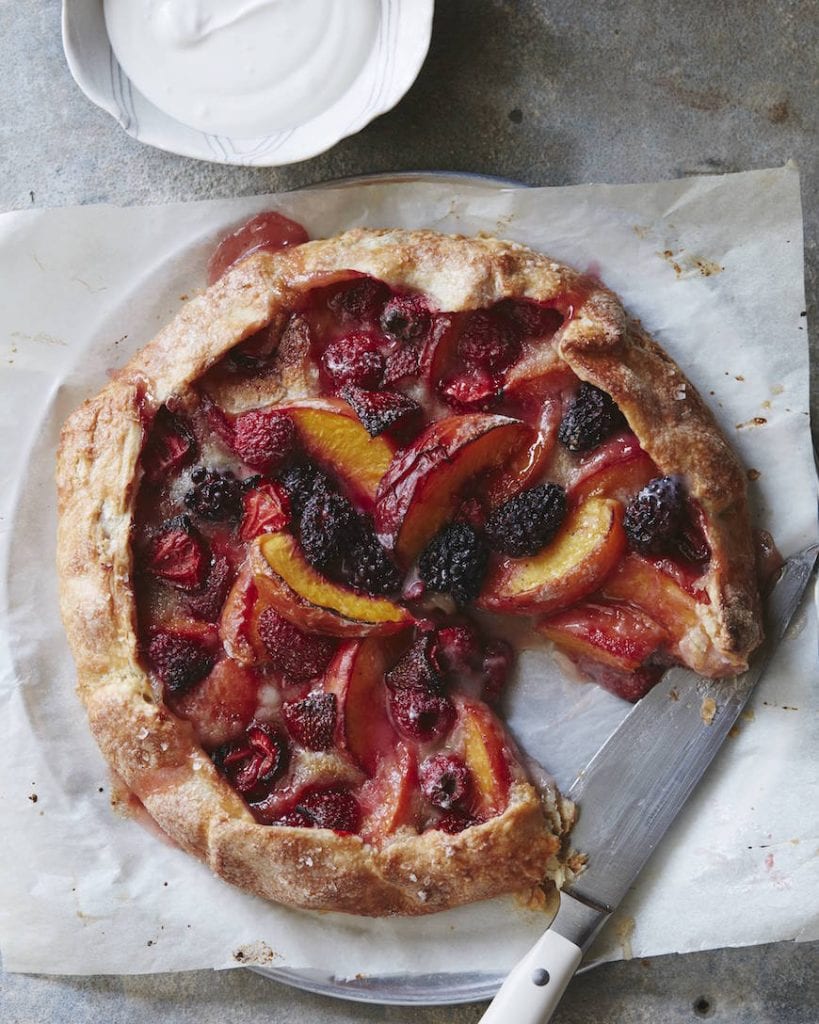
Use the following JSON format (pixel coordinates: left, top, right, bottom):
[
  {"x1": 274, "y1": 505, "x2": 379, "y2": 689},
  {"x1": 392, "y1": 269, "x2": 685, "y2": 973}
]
[{"x1": 58, "y1": 215, "x2": 760, "y2": 914}]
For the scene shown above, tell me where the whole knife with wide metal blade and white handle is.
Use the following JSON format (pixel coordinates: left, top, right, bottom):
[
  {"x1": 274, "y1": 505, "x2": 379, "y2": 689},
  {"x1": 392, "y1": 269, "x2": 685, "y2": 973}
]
[{"x1": 481, "y1": 545, "x2": 819, "y2": 1024}]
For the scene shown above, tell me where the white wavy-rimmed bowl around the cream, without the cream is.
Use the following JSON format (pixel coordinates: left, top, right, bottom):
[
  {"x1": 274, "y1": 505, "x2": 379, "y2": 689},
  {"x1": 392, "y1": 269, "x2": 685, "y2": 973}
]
[{"x1": 62, "y1": 0, "x2": 434, "y2": 167}]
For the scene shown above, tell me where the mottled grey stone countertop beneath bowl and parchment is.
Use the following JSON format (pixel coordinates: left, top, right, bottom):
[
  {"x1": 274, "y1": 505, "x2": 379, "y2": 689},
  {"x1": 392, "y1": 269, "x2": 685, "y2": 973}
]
[{"x1": 0, "y1": 0, "x2": 819, "y2": 1024}]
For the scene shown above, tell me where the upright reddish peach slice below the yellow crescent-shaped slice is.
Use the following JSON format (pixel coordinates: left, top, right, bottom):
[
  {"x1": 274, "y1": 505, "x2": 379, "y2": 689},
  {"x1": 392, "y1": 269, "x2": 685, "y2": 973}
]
[{"x1": 325, "y1": 637, "x2": 400, "y2": 775}]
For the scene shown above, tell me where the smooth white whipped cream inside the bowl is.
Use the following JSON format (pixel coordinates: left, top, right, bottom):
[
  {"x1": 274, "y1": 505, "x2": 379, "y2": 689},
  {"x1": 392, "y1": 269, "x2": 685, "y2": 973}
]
[{"x1": 104, "y1": 0, "x2": 381, "y2": 138}]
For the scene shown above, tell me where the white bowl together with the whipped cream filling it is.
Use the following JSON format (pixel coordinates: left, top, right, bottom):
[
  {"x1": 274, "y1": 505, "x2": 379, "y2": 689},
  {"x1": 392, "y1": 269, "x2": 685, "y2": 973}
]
[{"x1": 62, "y1": 0, "x2": 433, "y2": 166}]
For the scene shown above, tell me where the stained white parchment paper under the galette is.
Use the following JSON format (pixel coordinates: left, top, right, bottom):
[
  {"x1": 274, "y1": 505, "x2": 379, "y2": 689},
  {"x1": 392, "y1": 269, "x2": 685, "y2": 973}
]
[{"x1": 0, "y1": 168, "x2": 819, "y2": 977}]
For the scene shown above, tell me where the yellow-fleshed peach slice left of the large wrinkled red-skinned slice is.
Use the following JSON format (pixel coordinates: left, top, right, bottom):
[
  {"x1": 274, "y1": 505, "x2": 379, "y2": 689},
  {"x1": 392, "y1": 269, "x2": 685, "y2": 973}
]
[{"x1": 276, "y1": 398, "x2": 395, "y2": 506}]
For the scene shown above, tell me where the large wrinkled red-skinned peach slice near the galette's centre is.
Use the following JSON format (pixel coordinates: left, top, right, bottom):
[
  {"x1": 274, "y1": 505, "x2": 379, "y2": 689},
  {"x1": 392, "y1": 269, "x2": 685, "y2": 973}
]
[{"x1": 375, "y1": 413, "x2": 537, "y2": 562}]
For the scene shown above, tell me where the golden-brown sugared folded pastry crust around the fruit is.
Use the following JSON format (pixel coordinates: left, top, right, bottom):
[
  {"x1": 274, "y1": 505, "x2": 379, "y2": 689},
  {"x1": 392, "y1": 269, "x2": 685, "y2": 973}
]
[{"x1": 57, "y1": 230, "x2": 759, "y2": 914}]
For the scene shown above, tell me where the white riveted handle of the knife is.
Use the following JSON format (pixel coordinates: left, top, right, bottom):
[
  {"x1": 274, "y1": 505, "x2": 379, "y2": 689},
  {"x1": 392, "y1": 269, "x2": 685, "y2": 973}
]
[{"x1": 480, "y1": 929, "x2": 583, "y2": 1024}]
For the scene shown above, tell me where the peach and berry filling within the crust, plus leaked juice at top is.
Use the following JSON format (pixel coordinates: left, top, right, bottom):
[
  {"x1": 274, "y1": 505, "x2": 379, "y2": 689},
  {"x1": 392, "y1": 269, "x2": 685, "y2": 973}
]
[{"x1": 133, "y1": 215, "x2": 724, "y2": 843}]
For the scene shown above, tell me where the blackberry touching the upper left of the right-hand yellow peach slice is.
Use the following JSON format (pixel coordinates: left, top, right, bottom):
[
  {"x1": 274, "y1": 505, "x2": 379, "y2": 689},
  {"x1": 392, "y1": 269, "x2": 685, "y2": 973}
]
[{"x1": 485, "y1": 483, "x2": 566, "y2": 558}]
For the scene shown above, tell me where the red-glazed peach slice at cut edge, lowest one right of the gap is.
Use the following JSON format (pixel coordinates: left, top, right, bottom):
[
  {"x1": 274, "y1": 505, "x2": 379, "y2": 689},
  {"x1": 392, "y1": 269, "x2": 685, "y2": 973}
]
[{"x1": 537, "y1": 601, "x2": 667, "y2": 672}]
